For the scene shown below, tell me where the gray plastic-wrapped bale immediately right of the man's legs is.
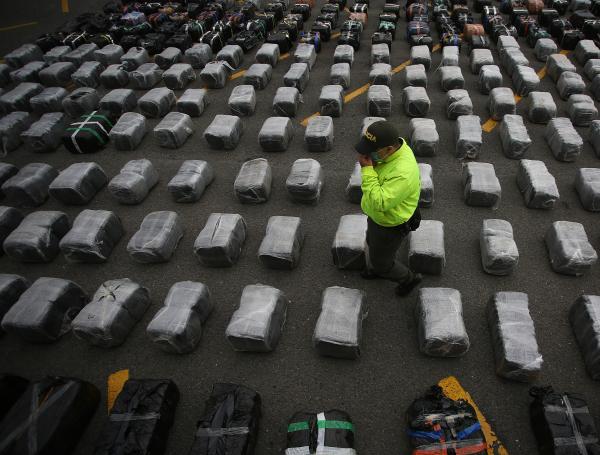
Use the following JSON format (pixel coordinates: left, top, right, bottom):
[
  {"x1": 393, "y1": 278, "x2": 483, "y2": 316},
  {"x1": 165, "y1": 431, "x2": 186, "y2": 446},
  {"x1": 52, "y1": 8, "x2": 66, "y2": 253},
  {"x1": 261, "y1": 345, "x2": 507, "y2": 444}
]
[{"x1": 408, "y1": 220, "x2": 446, "y2": 275}]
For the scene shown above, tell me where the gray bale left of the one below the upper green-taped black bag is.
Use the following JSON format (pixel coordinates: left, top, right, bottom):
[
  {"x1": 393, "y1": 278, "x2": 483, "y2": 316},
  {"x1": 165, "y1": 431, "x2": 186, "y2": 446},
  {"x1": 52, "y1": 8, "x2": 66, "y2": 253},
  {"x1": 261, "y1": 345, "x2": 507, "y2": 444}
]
[{"x1": 1, "y1": 163, "x2": 58, "y2": 207}]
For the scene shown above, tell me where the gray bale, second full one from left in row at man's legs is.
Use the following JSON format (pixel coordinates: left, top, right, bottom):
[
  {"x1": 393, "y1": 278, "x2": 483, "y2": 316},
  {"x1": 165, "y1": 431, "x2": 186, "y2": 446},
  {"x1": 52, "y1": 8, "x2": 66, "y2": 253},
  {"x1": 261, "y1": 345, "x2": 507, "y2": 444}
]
[{"x1": 60, "y1": 210, "x2": 124, "y2": 264}]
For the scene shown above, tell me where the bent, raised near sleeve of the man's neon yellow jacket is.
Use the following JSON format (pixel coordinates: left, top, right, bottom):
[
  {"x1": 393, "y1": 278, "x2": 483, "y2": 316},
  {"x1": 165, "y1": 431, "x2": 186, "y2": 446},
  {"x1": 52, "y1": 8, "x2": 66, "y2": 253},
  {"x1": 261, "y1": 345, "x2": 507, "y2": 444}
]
[{"x1": 361, "y1": 166, "x2": 409, "y2": 212}]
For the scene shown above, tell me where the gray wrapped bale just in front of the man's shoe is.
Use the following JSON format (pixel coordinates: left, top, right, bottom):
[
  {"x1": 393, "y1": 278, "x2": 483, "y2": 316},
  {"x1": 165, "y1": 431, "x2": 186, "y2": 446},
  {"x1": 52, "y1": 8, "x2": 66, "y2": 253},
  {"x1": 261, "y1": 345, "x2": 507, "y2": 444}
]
[{"x1": 415, "y1": 288, "x2": 477, "y2": 357}]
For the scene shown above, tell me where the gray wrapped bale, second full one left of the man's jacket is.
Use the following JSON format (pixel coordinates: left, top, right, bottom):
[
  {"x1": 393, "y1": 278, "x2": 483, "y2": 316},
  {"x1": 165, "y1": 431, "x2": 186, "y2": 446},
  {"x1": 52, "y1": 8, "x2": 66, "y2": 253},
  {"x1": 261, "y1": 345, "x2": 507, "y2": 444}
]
[{"x1": 233, "y1": 158, "x2": 272, "y2": 204}]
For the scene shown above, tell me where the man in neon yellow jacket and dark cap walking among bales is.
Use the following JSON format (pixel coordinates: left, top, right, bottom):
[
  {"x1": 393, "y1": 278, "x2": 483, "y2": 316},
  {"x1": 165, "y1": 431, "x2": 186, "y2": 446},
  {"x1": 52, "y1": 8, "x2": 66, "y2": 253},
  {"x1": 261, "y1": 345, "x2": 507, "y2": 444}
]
[{"x1": 355, "y1": 121, "x2": 423, "y2": 296}]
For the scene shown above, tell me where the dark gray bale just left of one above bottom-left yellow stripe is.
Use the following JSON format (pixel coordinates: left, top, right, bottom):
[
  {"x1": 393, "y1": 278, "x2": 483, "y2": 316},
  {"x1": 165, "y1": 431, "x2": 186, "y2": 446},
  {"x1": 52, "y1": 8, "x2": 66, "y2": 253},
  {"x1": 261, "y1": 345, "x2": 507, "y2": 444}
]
[{"x1": 2, "y1": 277, "x2": 88, "y2": 343}]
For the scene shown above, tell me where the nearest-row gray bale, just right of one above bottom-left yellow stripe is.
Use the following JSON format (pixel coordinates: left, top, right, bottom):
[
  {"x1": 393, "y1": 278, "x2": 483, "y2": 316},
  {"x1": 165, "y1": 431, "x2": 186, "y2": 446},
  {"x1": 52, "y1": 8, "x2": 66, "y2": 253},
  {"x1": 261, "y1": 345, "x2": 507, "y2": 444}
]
[{"x1": 146, "y1": 281, "x2": 214, "y2": 354}]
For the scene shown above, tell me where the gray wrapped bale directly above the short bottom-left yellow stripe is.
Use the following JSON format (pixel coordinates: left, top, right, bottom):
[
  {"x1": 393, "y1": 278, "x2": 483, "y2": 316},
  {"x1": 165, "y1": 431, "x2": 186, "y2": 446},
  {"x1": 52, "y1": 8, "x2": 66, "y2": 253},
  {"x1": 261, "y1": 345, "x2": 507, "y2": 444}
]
[{"x1": 72, "y1": 278, "x2": 150, "y2": 348}]
